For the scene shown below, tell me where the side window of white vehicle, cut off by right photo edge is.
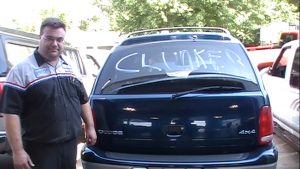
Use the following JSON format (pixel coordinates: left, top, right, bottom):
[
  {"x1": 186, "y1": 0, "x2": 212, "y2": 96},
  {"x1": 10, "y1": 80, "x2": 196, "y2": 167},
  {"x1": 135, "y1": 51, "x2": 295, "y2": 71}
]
[{"x1": 290, "y1": 48, "x2": 300, "y2": 89}]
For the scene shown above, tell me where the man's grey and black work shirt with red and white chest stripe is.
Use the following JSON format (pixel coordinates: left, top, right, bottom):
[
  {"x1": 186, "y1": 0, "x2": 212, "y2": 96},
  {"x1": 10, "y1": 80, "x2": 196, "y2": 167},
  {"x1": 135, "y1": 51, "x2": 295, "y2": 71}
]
[{"x1": 1, "y1": 50, "x2": 88, "y2": 143}]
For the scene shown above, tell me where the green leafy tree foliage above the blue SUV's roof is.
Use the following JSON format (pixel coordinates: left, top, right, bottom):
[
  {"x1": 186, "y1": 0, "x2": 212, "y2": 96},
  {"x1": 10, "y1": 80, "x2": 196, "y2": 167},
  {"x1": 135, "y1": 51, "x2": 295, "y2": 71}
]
[{"x1": 94, "y1": 0, "x2": 299, "y2": 43}]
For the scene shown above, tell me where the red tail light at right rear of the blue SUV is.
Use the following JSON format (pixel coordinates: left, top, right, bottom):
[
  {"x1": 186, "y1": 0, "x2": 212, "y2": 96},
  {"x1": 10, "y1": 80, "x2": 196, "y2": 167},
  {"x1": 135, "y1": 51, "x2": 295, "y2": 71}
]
[{"x1": 259, "y1": 106, "x2": 273, "y2": 145}]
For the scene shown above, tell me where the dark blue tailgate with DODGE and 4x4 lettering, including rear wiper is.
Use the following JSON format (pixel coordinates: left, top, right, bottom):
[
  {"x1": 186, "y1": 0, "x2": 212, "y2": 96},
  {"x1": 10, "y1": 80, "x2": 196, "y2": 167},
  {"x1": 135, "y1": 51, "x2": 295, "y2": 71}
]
[{"x1": 91, "y1": 76, "x2": 265, "y2": 154}]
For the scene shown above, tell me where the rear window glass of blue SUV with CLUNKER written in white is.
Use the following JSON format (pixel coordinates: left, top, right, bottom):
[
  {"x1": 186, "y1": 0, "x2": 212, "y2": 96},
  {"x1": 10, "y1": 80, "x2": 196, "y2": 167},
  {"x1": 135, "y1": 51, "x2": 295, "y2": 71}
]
[{"x1": 97, "y1": 41, "x2": 257, "y2": 93}]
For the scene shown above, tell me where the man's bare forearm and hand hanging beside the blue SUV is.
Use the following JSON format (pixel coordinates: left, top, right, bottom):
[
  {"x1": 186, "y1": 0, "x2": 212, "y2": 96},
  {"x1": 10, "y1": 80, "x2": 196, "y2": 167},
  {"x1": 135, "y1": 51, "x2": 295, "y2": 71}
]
[{"x1": 81, "y1": 102, "x2": 97, "y2": 145}]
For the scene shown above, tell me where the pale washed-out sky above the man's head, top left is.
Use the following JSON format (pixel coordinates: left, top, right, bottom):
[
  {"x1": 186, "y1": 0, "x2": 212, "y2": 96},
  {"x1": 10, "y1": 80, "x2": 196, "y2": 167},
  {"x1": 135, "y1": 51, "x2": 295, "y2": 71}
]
[{"x1": 0, "y1": 0, "x2": 107, "y2": 32}]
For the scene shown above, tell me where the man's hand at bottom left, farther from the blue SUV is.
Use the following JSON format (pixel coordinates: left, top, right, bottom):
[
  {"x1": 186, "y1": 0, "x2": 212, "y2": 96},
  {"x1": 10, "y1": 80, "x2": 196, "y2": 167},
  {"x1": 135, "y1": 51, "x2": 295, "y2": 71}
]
[{"x1": 13, "y1": 149, "x2": 34, "y2": 169}]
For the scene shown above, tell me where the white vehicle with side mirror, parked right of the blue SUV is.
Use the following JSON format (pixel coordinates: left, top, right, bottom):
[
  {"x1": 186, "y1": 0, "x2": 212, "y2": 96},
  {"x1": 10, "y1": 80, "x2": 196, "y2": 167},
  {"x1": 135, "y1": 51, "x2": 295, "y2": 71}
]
[{"x1": 261, "y1": 40, "x2": 300, "y2": 151}]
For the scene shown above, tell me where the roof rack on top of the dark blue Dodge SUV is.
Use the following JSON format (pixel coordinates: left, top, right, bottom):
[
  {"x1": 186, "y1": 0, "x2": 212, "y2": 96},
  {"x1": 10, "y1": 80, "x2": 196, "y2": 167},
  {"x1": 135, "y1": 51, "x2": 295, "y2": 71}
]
[{"x1": 127, "y1": 27, "x2": 230, "y2": 38}]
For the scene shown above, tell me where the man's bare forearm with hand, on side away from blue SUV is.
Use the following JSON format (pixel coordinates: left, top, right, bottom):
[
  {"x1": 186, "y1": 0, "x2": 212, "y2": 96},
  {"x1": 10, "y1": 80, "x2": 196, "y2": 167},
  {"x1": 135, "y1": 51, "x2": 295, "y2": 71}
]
[{"x1": 4, "y1": 114, "x2": 34, "y2": 169}]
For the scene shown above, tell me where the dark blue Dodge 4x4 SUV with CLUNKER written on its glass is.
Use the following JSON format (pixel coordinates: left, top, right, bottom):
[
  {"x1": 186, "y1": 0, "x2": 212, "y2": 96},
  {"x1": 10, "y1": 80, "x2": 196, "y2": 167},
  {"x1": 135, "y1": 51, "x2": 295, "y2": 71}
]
[{"x1": 81, "y1": 27, "x2": 278, "y2": 169}]
